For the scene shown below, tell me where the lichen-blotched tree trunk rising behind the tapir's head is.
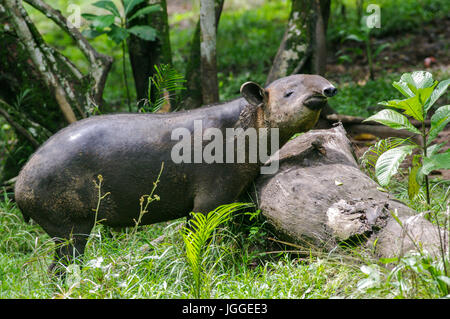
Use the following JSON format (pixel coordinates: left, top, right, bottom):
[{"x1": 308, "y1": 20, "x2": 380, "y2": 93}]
[{"x1": 266, "y1": 0, "x2": 330, "y2": 85}]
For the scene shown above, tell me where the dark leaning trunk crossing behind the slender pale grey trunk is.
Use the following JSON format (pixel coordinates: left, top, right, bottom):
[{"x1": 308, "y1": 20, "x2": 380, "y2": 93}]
[{"x1": 182, "y1": 0, "x2": 224, "y2": 109}]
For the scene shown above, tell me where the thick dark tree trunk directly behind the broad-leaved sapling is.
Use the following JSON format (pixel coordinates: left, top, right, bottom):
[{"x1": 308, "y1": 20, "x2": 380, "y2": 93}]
[{"x1": 128, "y1": 0, "x2": 172, "y2": 102}]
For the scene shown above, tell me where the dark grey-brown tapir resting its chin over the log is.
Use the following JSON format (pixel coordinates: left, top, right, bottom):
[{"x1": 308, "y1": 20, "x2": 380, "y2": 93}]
[{"x1": 15, "y1": 74, "x2": 337, "y2": 268}]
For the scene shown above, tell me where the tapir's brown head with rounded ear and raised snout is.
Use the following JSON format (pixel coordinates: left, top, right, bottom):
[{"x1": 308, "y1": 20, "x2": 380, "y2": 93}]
[{"x1": 241, "y1": 74, "x2": 337, "y2": 141}]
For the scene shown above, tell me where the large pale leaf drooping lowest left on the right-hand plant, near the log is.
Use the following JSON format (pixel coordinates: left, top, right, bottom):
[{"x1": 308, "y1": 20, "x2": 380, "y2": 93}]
[{"x1": 375, "y1": 145, "x2": 416, "y2": 186}]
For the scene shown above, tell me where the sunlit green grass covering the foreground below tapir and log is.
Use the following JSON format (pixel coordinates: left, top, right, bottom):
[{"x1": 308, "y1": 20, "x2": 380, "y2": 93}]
[{"x1": 0, "y1": 188, "x2": 449, "y2": 299}]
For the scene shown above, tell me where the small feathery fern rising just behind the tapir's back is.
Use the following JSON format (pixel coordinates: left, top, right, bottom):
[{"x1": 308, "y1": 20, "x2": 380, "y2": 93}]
[{"x1": 140, "y1": 64, "x2": 186, "y2": 112}]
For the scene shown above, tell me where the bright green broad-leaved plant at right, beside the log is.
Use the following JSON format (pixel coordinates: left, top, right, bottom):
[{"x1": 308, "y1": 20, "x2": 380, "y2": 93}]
[{"x1": 365, "y1": 71, "x2": 450, "y2": 205}]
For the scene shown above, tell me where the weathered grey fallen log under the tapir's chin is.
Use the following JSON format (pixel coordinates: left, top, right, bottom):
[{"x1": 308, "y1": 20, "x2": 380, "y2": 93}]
[{"x1": 256, "y1": 124, "x2": 448, "y2": 257}]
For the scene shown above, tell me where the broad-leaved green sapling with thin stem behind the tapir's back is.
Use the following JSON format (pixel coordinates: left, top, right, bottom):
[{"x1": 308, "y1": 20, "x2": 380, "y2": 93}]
[{"x1": 82, "y1": 0, "x2": 161, "y2": 112}]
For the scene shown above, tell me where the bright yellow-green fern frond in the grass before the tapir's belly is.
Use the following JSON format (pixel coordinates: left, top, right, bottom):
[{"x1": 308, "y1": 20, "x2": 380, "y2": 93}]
[{"x1": 181, "y1": 203, "x2": 253, "y2": 298}]
